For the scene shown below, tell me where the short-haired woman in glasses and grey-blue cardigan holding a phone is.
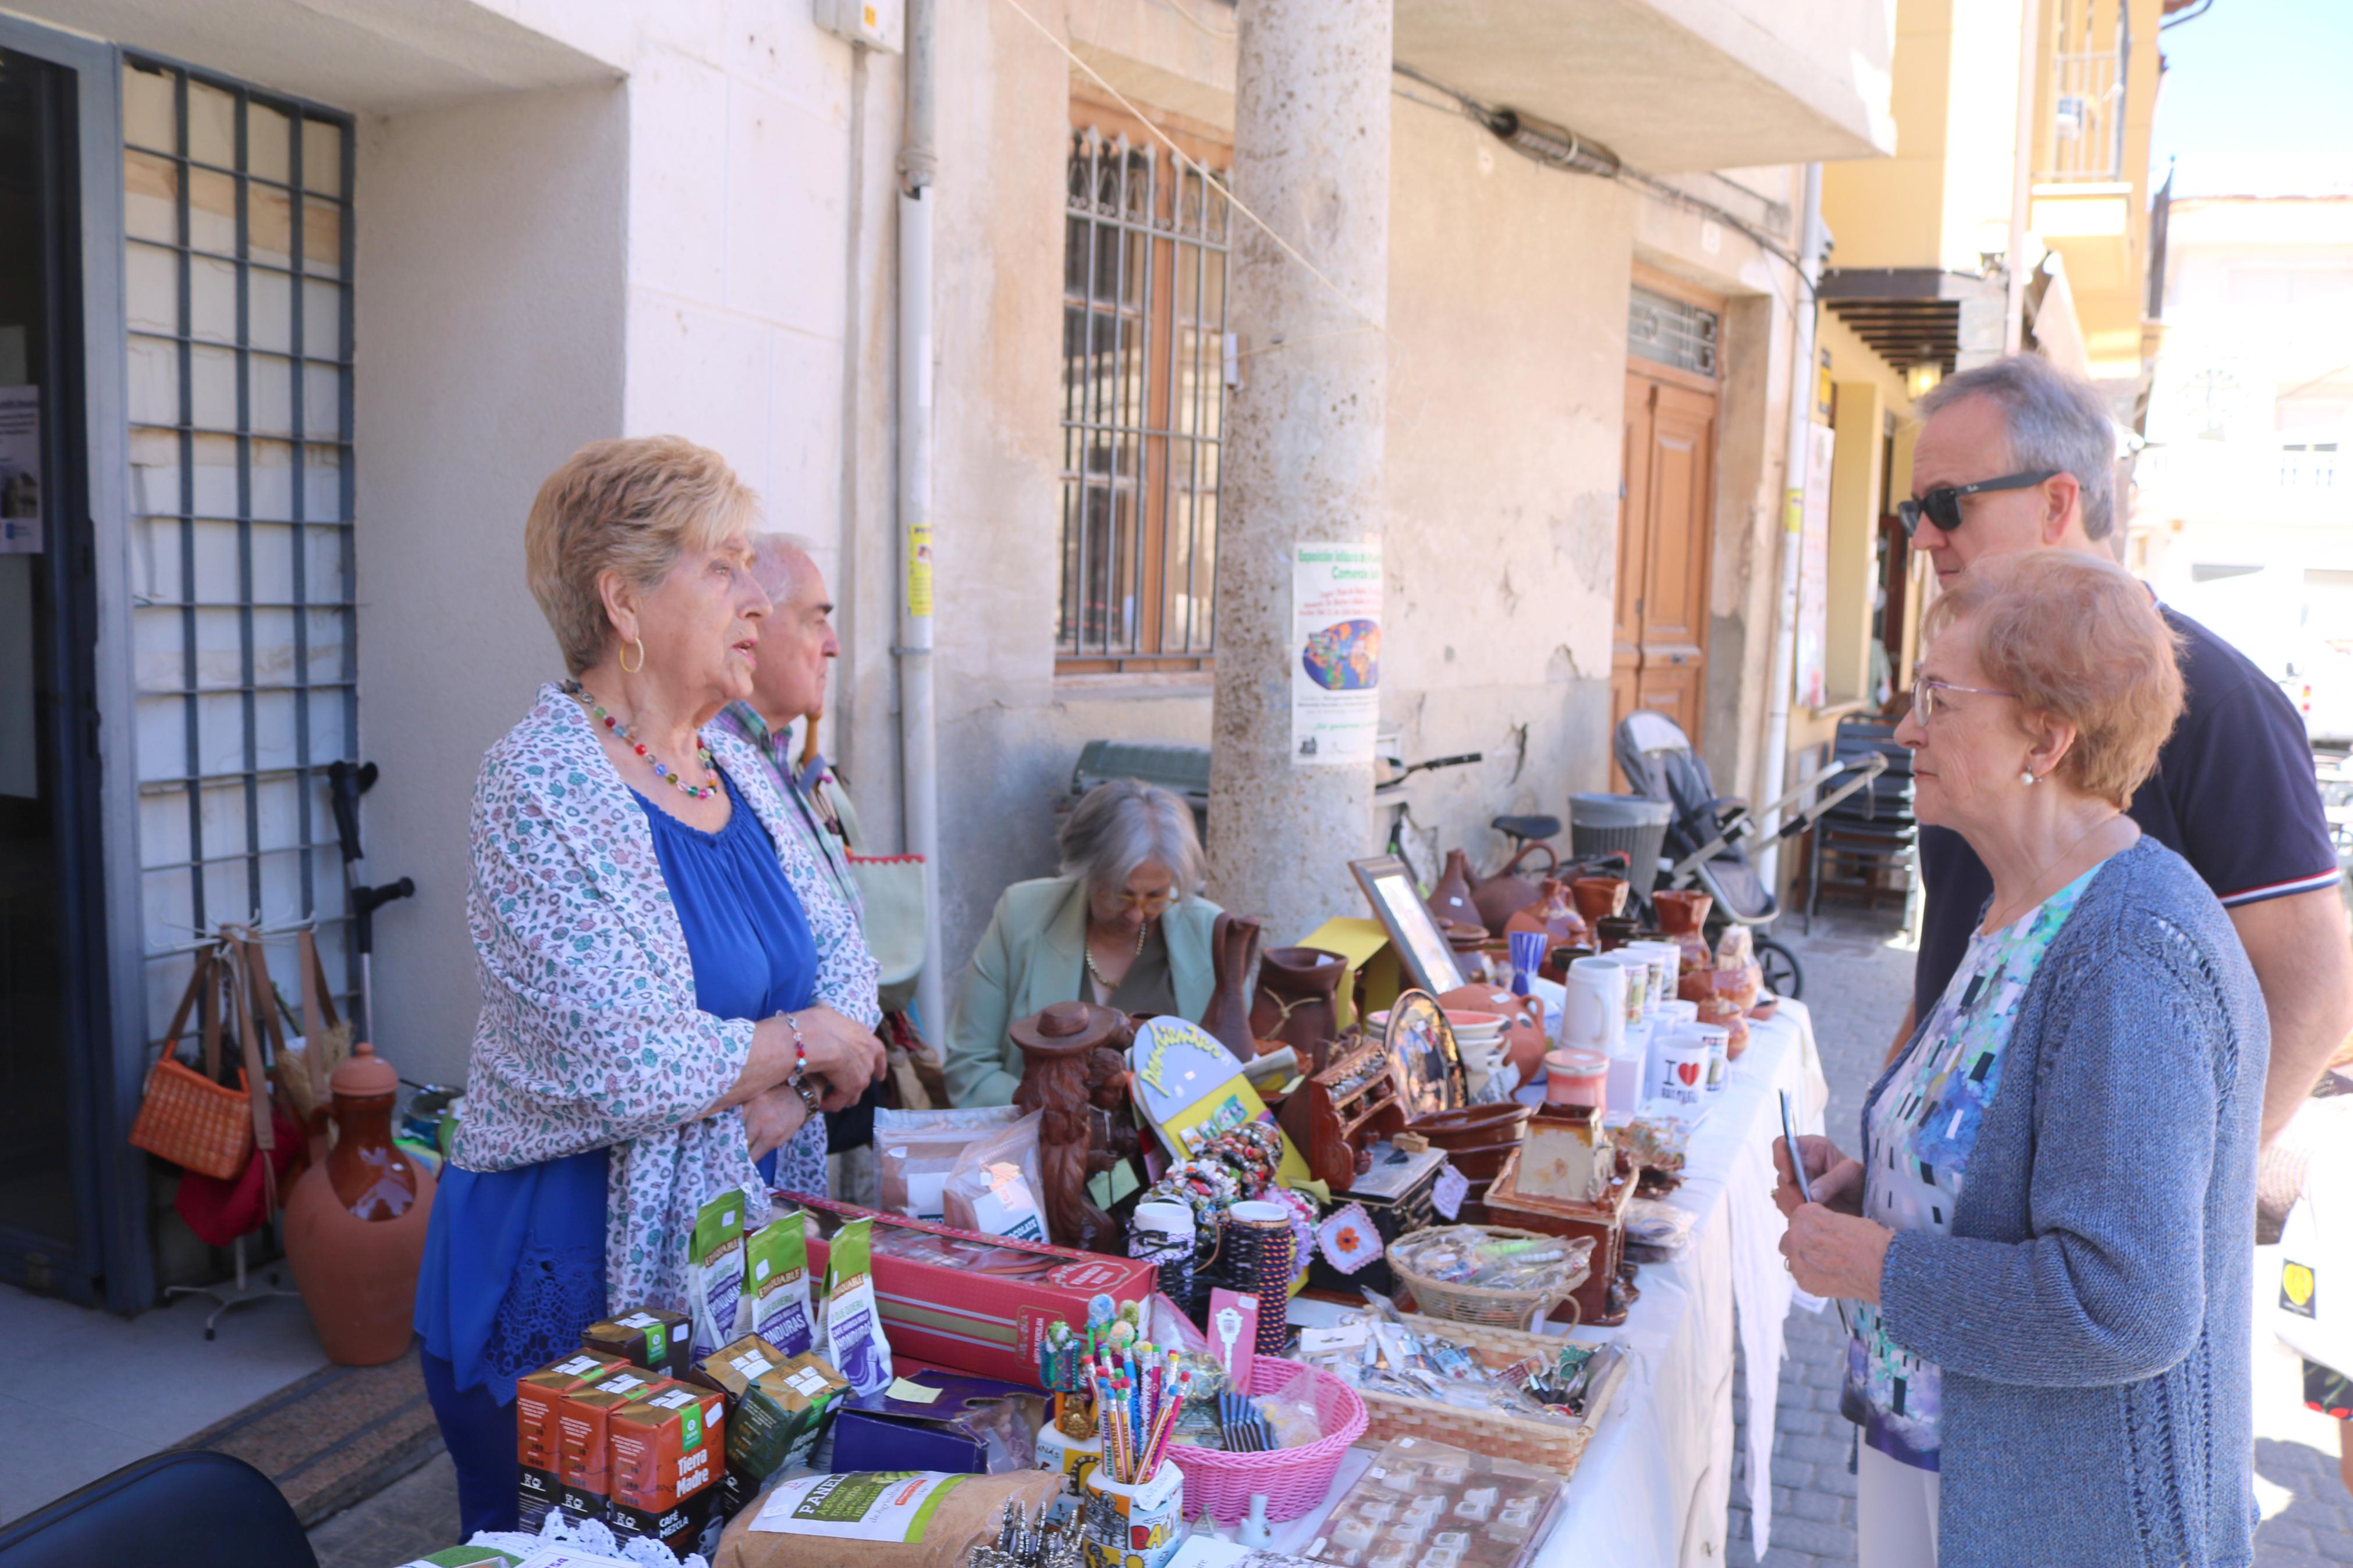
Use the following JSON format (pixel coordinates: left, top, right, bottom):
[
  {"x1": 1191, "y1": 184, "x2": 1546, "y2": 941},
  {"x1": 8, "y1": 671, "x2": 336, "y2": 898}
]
[{"x1": 1774, "y1": 550, "x2": 2270, "y2": 1568}]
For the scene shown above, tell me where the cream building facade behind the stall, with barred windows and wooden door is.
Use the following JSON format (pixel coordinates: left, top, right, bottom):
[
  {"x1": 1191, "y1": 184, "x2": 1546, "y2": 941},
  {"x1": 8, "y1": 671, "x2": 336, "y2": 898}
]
[{"x1": 0, "y1": 0, "x2": 1897, "y2": 1345}]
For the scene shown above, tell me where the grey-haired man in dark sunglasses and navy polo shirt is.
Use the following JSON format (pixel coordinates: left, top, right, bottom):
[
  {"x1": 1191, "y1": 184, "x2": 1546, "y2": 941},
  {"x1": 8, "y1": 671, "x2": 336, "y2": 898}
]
[{"x1": 1890, "y1": 355, "x2": 2353, "y2": 1189}]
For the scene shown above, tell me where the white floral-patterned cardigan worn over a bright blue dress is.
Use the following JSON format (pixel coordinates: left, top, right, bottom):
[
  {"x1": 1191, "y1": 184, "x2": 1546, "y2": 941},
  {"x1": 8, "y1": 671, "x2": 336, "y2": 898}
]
[{"x1": 452, "y1": 687, "x2": 880, "y2": 1307}]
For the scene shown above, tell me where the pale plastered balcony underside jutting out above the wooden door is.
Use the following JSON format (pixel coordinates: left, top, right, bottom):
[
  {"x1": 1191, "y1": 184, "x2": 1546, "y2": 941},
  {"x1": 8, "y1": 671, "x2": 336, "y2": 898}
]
[{"x1": 1395, "y1": 0, "x2": 1894, "y2": 174}]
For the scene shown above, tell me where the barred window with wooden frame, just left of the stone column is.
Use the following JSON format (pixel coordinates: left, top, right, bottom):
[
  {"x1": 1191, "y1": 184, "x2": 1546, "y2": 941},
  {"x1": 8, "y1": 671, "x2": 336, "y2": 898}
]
[{"x1": 1054, "y1": 104, "x2": 1230, "y2": 675}]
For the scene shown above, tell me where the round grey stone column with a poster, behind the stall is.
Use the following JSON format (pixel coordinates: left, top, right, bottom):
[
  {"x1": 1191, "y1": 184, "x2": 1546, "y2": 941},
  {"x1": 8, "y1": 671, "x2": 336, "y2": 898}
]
[{"x1": 1209, "y1": 0, "x2": 1390, "y2": 943}]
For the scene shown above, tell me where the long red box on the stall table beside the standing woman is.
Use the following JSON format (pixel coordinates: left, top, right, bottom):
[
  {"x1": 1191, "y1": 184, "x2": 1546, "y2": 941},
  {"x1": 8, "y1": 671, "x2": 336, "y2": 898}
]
[{"x1": 781, "y1": 1192, "x2": 1158, "y2": 1387}]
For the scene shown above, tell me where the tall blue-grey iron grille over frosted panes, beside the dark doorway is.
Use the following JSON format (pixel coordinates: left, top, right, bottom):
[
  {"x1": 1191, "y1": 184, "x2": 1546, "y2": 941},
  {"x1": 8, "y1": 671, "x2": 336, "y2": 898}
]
[{"x1": 122, "y1": 56, "x2": 358, "y2": 1034}]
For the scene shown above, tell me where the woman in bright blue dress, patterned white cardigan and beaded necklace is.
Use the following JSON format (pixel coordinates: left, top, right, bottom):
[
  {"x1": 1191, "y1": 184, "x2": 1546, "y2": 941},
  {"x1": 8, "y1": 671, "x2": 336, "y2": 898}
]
[{"x1": 417, "y1": 438, "x2": 882, "y2": 1535}]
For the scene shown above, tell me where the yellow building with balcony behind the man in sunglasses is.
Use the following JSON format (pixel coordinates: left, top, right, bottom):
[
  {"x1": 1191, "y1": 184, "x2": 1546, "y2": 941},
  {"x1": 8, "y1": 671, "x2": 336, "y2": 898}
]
[{"x1": 1788, "y1": 0, "x2": 2181, "y2": 902}]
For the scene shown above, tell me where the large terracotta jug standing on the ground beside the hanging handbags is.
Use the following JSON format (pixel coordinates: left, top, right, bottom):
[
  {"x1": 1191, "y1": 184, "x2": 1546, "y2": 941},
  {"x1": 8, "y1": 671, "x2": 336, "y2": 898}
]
[{"x1": 285, "y1": 1041, "x2": 433, "y2": 1366}]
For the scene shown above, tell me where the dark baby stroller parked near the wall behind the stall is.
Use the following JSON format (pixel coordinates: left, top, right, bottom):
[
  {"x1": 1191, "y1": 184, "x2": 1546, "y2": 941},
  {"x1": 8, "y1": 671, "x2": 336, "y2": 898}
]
[{"x1": 1612, "y1": 707, "x2": 1887, "y2": 997}]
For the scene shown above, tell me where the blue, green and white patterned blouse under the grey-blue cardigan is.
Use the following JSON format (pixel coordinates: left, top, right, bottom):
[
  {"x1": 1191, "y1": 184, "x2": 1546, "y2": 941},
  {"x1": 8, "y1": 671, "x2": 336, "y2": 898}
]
[{"x1": 1838, "y1": 861, "x2": 2106, "y2": 1469}]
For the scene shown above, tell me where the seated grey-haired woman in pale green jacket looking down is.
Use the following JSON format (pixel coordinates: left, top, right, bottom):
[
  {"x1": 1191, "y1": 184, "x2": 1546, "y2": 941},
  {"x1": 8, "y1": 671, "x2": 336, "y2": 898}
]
[{"x1": 943, "y1": 778, "x2": 1219, "y2": 1105}]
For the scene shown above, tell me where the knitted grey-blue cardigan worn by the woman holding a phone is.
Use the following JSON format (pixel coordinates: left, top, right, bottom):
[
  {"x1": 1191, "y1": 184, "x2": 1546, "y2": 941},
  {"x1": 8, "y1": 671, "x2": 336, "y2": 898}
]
[{"x1": 1864, "y1": 837, "x2": 2270, "y2": 1568}]
